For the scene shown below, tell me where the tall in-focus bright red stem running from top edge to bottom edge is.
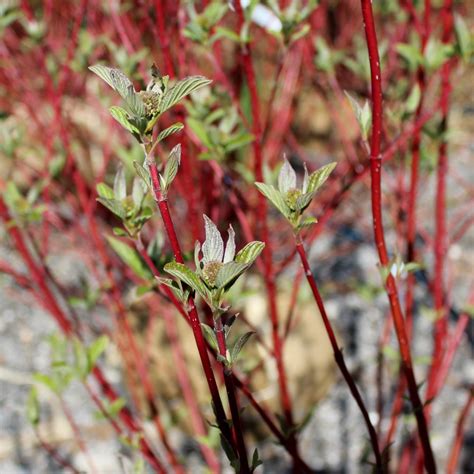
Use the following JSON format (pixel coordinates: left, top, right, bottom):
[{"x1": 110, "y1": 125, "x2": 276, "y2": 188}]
[{"x1": 361, "y1": 0, "x2": 436, "y2": 474}]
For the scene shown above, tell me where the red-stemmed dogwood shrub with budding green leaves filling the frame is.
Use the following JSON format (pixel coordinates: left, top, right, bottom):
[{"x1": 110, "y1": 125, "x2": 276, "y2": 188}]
[{"x1": 0, "y1": 0, "x2": 474, "y2": 473}]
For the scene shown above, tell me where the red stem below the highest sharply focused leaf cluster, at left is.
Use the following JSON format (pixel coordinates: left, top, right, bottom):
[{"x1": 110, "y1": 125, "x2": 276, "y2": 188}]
[{"x1": 145, "y1": 146, "x2": 233, "y2": 446}]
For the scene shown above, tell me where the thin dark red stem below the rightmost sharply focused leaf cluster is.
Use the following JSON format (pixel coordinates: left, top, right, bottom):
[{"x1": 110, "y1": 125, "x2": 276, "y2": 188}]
[{"x1": 296, "y1": 236, "x2": 383, "y2": 473}]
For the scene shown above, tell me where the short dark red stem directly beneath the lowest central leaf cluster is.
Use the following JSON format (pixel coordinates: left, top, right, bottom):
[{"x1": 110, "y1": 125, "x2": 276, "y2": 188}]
[{"x1": 214, "y1": 316, "x2": 250, "y2": 474}]
